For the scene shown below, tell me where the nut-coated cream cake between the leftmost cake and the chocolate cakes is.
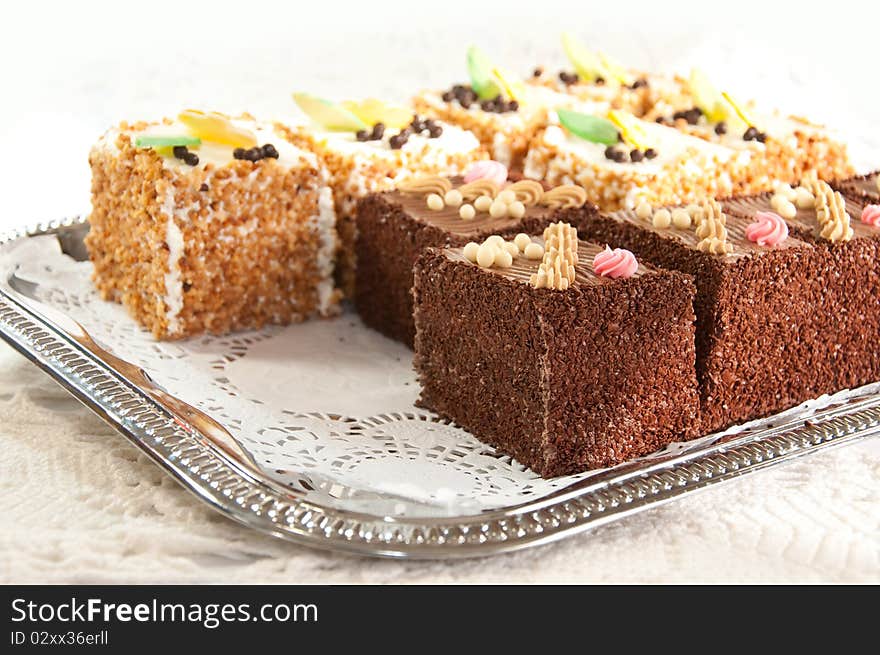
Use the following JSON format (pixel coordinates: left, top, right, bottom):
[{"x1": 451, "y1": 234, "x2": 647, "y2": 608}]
[{"x1": 285, "y1": 94, "x2": 486, "y2": 297}]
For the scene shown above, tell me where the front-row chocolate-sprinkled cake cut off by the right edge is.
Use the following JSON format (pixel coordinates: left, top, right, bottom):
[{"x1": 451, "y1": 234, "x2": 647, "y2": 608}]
[{"x1": 725, "y1": 183, "x2": 880, "y2": 392}]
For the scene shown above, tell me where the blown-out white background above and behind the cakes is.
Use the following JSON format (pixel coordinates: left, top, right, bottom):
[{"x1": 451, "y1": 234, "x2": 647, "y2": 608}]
[{"x1": 0, "y1": 0, "x2": 880, "y2": 227}]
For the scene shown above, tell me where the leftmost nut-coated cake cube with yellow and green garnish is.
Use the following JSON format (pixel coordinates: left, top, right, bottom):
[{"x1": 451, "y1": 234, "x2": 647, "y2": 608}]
[{"x1": 86, "y1": 110, "x2": 340, "y2": 339}]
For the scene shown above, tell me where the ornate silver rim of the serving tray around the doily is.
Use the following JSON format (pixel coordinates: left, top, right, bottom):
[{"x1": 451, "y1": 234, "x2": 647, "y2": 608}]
[{"x1": 0, "y1": 219, "x2": 880, "y2": 558}]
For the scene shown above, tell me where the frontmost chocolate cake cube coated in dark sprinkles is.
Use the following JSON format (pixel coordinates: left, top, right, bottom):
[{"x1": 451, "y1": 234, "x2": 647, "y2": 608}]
[{"x1": 414, "y1": 231, "x2": 699, "y2": 477}]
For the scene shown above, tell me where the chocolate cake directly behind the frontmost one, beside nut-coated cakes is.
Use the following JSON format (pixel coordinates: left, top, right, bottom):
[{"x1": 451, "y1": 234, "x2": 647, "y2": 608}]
[{"x1": 355, "y1": 173, "x2": 596, "y2": 348}]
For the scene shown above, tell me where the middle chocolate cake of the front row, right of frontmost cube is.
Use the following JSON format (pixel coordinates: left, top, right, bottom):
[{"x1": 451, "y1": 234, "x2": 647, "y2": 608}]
[{"x1": 581, "y1": 203, "x2": 824, "y2": 433}]
